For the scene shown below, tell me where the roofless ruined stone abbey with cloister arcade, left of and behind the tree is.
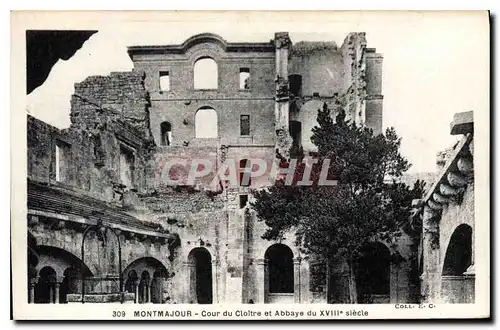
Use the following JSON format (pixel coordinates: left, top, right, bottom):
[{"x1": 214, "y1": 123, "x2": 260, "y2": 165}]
[{"x1": 28, "y1": 33, "x2": 419, "y2": 303}]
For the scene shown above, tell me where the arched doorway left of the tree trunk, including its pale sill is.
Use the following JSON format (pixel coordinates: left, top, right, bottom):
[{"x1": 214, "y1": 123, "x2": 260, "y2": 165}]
[{"x1": 264, "y1": 244, "x2": 294, "y2": 303}]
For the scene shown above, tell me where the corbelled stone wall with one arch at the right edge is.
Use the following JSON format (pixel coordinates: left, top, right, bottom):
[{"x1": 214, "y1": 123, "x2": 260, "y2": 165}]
[{"x1": 416, "y1": 111, "x2": 475, "y2": 303}]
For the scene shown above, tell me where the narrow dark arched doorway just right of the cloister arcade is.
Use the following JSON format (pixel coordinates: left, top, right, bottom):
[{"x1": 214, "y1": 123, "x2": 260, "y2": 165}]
[{"x1": 188, "y1": 247, "x2": 213, "y2": 304}]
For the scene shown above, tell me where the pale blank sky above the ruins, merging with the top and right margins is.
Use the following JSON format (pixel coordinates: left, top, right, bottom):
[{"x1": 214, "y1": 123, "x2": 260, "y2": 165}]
[{"x1": 26, "y1": 11, "x2": 489, "y2": 173}]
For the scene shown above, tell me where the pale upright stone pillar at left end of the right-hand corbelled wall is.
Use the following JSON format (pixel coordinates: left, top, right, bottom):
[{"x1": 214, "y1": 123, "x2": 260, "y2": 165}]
[{"x1": 421, "y1": 206, "x2": 441, "y2": 303}]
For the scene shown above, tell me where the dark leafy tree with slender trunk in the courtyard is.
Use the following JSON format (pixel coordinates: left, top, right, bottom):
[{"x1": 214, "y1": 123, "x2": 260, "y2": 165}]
[{"x1": 251, "y1": 104, "x2": 423, "y2": 303}]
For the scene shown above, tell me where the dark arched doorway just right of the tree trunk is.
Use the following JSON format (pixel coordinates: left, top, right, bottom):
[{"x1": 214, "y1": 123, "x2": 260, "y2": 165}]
[{"x1": 356, "y1": 243, "x2": 391, "y2": 304}]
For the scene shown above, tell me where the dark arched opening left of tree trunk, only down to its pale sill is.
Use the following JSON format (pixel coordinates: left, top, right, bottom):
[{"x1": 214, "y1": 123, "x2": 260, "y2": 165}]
[{"x1": 265, "y1": 244, "x2": 294, "y2": 293}]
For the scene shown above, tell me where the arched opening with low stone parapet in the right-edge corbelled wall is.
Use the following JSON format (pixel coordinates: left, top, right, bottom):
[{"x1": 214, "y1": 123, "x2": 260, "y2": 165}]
[{"x1": 441, "y1": 224, "x2": 475, "y2": 303}]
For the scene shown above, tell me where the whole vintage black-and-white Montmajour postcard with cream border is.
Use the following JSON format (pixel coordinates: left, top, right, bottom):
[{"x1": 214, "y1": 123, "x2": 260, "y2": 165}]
[{"x1": 11, "y1": 11, "x2": 490, "y2": 321}]
